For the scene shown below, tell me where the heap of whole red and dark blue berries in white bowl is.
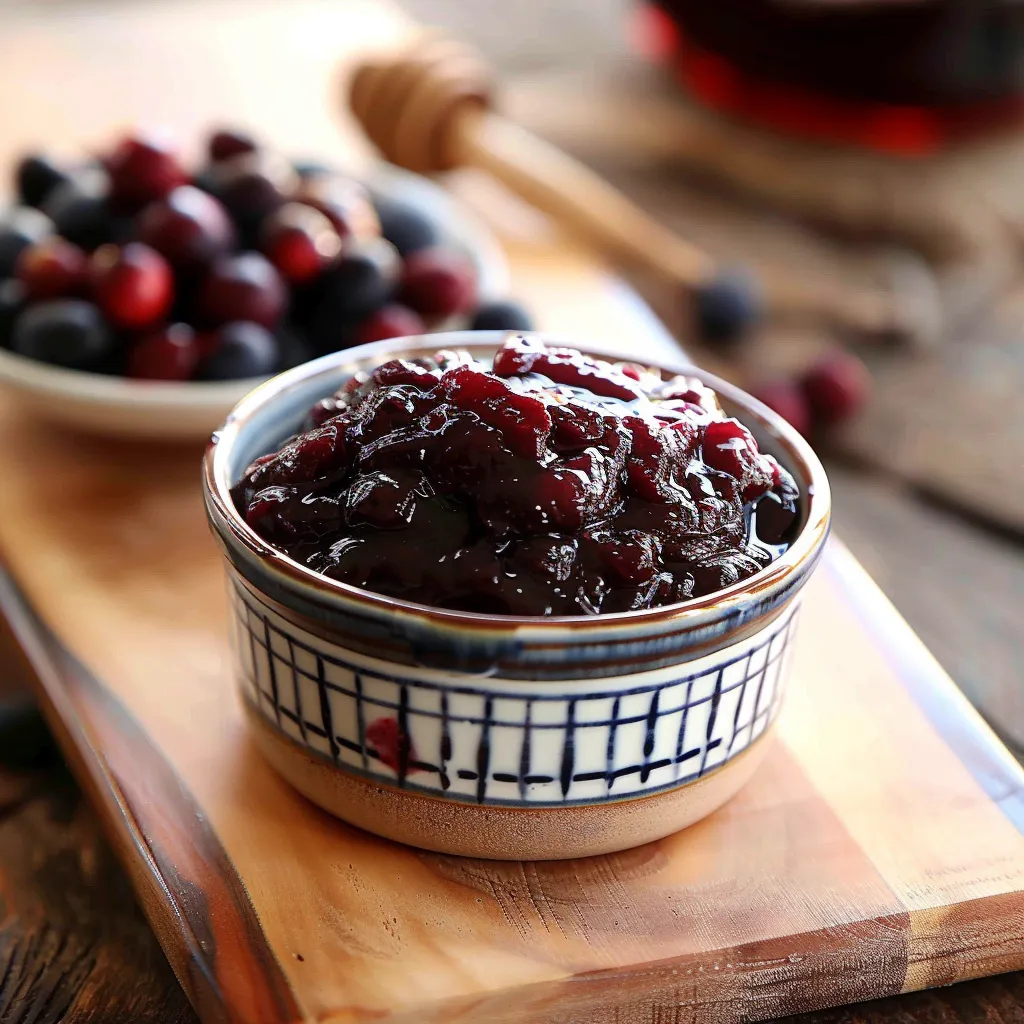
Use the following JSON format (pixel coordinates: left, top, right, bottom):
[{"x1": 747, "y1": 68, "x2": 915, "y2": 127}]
[{"x1": 0, "y1": 131, "x2": 530, "y2": 381}]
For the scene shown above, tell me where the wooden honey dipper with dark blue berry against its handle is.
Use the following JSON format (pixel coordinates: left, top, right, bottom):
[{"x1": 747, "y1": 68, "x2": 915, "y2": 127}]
[{"x1": 348, "y1": 32, "x2": 929, "y2": 348}]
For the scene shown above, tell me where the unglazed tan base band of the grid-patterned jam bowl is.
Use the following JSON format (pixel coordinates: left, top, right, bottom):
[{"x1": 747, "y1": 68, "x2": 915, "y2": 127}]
[{"x1": 245, "y1": 701, "x2": 774, "y2": 860}]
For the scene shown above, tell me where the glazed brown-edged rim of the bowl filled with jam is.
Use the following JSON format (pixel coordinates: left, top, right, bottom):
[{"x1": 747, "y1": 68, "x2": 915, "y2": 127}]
[{"x1": 203, "y1": 331, "x2": 831, "y2": 639}]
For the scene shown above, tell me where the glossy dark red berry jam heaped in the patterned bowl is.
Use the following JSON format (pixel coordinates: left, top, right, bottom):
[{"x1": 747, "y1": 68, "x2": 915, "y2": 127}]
[{"x1": 232, "y1": 337, "x2": 801, "y2": 615}]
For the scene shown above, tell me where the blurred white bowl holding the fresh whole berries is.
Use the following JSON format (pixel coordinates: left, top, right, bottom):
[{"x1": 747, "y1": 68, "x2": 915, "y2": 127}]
[{"x1": 0, "y1": 164, "x2": 509, "y2": 440}]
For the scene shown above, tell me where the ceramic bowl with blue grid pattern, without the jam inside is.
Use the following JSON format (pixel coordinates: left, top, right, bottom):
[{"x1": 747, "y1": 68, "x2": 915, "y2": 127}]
[{"x1": 205, "y1": 333, "x2": 829, "y2": 859}]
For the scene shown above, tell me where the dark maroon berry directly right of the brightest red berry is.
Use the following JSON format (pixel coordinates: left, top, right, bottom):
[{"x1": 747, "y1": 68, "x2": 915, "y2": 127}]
[{"x1": 196, "y1": 252, "x2": 288, "y2": 328}]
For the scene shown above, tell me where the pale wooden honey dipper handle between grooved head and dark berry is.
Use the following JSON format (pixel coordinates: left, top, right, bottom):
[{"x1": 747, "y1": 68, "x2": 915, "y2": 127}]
[{"x1": 460, "y1": 112, "x2": 715, "y2": 289}]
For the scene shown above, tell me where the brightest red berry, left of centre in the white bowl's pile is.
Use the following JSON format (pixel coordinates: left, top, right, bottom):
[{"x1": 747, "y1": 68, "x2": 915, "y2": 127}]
[{"x1": 92, "y1": 242, "x2": 174, "y2": 328}]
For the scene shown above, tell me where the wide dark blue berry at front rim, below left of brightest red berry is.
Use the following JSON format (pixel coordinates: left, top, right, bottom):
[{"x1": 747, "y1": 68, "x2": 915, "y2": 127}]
[{"x1": 10, "y1": 299, "x2": 117, "y2": 371}]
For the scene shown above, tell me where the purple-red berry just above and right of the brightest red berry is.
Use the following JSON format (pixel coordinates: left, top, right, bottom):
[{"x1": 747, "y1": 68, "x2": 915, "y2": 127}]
[{"x1": 138, "y1": 185, "x2": 236, "y2": 273}]
